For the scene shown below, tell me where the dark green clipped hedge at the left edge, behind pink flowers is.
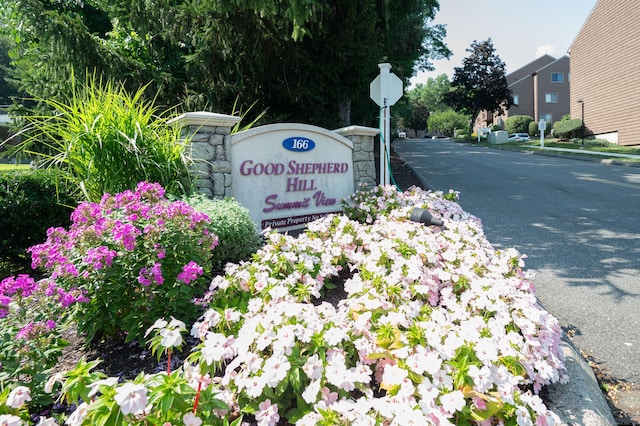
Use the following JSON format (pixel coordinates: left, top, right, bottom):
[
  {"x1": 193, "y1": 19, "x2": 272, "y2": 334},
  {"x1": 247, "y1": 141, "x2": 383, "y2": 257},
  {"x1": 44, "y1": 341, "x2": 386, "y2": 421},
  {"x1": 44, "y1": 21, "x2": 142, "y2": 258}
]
[{"x1": 0, "y1": 170, "x2": 78, "y2": 264}]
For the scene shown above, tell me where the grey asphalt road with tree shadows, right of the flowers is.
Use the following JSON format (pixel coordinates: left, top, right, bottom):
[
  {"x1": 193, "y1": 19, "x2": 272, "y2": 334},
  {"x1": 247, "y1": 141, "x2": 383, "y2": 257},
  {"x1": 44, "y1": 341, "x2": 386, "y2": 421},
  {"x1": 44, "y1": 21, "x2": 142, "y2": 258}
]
[{"x1": 393, "y1": 139, "x2": 640, "y2": 385}]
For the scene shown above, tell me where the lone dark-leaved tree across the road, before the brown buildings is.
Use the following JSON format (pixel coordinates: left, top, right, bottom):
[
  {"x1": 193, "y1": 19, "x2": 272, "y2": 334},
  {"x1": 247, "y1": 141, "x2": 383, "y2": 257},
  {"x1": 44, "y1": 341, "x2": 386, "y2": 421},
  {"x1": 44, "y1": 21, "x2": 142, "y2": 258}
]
[{"x1": 444, "y1": 39, "x2": 513, "y2": 130}]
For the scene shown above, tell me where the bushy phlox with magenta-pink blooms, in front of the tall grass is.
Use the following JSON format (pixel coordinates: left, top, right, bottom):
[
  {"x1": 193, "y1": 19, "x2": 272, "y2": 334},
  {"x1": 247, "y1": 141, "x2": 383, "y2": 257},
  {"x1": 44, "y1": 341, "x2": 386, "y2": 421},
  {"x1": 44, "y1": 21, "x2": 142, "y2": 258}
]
[{"x1": 29, "y1": 182, "x2": 217, "y2": 341}]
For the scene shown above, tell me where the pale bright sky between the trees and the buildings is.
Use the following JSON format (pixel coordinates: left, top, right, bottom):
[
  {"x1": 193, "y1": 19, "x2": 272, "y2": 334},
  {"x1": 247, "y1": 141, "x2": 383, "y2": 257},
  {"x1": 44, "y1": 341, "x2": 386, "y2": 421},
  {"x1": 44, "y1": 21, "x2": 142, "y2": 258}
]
[{"x1": 410, "y1": 0, "x2": 597, "y2": 87}]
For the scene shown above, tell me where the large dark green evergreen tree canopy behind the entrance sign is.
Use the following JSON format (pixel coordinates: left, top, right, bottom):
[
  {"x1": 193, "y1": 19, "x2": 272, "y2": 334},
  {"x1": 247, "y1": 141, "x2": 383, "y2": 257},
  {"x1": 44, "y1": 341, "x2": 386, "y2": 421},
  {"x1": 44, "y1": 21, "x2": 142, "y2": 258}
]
[{"x1": 2, "y1": 0, "x2": 450, "y2": 126}]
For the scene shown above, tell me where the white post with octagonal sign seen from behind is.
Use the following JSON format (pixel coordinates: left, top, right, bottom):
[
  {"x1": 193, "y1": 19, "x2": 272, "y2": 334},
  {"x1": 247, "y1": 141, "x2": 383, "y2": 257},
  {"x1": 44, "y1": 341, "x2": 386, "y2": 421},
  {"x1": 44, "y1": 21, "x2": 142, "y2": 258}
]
[{"x1": 369, "y1": 63, "x2": 403, "y2": 185}]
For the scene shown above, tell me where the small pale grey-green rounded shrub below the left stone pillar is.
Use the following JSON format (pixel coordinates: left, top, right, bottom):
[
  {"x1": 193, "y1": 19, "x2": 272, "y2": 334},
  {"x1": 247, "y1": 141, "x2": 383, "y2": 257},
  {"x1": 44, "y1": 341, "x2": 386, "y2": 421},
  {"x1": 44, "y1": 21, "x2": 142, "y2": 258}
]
[{"x1": 184, "y1": 194, "x2": 261, "y2": 269}]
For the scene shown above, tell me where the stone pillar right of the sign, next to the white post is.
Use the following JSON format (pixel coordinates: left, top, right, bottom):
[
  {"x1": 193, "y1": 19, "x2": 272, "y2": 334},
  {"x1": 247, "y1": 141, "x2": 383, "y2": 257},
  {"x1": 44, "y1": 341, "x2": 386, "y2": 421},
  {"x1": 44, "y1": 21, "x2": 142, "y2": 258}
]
[{"x1": 334, "y1": 126, "x2": 380, "y2": 190}]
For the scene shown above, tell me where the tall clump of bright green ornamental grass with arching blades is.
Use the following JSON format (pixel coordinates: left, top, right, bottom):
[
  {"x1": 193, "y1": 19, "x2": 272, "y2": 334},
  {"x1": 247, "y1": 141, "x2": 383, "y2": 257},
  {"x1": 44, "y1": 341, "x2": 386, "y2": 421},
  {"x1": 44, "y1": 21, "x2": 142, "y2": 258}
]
[{"x1": 11, "y1": 78, "x2": 192, "y2": 201}]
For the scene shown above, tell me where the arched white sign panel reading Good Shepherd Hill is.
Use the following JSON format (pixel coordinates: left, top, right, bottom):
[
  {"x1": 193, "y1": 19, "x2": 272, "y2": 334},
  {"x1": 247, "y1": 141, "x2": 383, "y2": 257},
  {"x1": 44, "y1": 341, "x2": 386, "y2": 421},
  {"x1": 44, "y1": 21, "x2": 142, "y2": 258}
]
[{"x1": 231, "y1": 124, "x2": 354, "y2": 231}]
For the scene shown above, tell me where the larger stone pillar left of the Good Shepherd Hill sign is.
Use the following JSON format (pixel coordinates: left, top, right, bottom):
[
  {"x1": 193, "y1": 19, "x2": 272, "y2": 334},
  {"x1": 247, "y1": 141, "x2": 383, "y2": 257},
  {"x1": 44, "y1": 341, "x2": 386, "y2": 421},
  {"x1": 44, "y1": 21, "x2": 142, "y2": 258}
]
[{"x1": 169, "y1": 111, "x2": 241, "y2": 198}]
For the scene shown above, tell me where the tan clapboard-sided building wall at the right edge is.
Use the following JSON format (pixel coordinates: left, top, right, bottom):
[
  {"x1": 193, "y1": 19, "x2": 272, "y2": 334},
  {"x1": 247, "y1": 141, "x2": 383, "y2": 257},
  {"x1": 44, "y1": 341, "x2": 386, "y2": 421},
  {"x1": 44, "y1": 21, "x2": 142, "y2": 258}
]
[{"x1": 571, "y1": 0, "x2": 640, "y2": 145}]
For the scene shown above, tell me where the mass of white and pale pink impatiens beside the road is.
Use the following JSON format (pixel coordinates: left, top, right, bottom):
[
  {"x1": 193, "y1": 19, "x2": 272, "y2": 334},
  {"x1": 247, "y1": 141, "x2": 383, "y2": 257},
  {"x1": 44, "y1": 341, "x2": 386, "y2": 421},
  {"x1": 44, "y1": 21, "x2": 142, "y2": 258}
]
[{"x1": 2, "y1": 187, "x2": 566, "y2": 425}]
